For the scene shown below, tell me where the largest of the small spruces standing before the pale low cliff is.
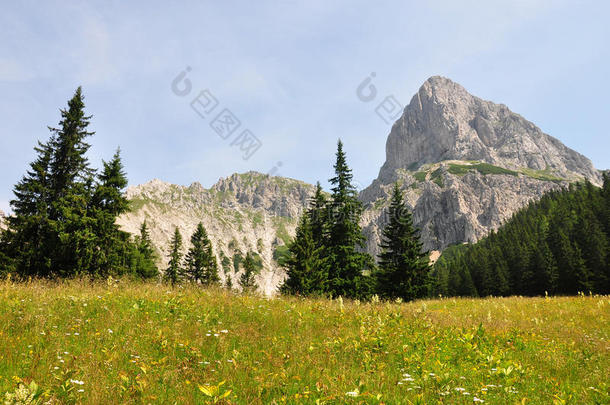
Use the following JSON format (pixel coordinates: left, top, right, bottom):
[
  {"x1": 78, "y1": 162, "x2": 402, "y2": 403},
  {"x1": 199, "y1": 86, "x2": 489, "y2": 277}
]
[{"x1": 185, "y1": 222, "x2": 220, "y2": 285}]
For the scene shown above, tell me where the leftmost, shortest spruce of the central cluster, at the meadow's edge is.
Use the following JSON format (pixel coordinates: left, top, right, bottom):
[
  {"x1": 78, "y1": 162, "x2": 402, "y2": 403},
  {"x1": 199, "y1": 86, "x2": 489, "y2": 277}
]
[{"x1": 280, "y1": 213, "x2": 326, "y2": 295}]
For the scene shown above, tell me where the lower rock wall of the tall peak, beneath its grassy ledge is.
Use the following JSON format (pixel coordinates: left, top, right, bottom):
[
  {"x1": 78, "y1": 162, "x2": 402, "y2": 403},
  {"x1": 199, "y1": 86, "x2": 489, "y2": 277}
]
[{"x1": 362, "y1": 161, "x2": 569, "y2": 255}]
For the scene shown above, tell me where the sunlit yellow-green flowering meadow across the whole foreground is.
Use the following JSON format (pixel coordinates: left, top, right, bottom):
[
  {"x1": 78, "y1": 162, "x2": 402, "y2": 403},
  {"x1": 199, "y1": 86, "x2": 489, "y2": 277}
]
[{"x1": 0, "y1": 280, "x2": 610, "y2": 404}]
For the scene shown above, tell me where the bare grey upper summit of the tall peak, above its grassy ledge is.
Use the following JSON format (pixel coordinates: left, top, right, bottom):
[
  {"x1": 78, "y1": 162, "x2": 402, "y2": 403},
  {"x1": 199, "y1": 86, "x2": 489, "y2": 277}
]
[{"x1": 379, "y1": 76, "x2": 601, "y2": 184}]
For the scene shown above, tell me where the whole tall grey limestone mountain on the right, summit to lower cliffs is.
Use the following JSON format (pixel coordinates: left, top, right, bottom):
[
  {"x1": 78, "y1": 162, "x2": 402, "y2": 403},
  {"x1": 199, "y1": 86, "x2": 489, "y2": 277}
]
[{"x1": 360, "y1": 76, "x2": 601, "y2": 253}]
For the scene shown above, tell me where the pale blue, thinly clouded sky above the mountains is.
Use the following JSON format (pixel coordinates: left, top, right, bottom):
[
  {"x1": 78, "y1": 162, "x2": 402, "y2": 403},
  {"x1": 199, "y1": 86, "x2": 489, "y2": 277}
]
[{"x1": 0, "y1": 0, "x2": 610, "y2": 211}]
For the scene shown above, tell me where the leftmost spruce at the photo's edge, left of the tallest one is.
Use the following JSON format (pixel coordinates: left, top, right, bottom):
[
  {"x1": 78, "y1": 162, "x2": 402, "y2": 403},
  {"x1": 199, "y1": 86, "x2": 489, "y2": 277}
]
[{"x1": 1, "y1": 142, "x2": 53, "y2": 277}]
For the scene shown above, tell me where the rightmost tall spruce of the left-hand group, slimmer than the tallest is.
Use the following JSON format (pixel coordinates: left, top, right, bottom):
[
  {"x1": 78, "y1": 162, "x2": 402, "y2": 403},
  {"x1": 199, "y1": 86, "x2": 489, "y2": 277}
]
[{"x1": 92, "y1": 149, "x2": 129, "y2": 276}]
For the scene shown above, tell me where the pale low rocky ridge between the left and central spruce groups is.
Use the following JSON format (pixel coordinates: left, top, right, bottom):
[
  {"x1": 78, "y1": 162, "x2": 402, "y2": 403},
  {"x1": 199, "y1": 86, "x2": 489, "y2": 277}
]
[{"x1": 118, "y1": 172, "x2": 314, "y2": 294}]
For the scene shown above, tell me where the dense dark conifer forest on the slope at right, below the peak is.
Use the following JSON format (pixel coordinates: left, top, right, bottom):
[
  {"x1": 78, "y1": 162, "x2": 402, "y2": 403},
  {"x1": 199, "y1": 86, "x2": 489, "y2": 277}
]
[{"x1": 432, "y1": 178, "x2": 610, "y2": 296}]
